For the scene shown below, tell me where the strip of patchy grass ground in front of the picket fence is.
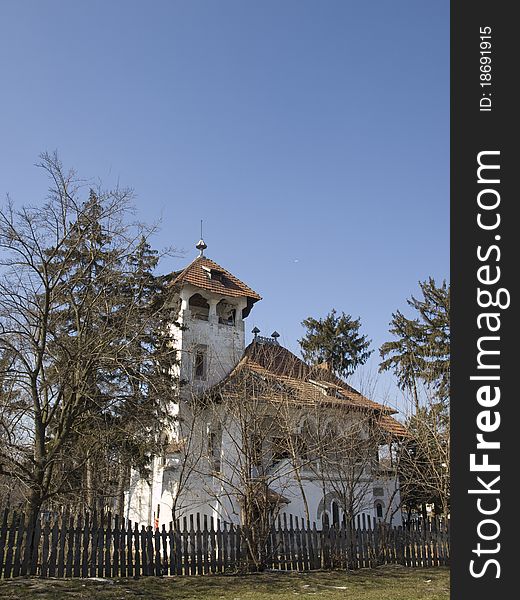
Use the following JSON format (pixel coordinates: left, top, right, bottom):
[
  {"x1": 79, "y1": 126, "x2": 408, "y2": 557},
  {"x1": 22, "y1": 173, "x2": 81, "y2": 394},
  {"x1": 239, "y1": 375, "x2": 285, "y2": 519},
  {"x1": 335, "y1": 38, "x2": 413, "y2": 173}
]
[{"x1": 0, "y1": 565, "x2": 449, "y2": 600}]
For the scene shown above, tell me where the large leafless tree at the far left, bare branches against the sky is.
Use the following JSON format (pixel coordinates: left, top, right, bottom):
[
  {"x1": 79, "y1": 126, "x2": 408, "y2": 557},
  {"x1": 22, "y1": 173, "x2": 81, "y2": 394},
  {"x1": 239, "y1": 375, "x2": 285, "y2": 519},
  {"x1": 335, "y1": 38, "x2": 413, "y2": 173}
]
[{"x1": 0, "y1": 154, "x2": 175, "y2": 519}]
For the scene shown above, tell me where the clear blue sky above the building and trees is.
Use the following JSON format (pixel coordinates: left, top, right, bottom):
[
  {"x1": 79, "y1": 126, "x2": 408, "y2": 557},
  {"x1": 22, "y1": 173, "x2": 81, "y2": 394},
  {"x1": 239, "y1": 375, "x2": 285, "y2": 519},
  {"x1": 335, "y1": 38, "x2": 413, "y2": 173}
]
[{"x1": 0, "y1": 0, "x2": 449, "y2": 412}]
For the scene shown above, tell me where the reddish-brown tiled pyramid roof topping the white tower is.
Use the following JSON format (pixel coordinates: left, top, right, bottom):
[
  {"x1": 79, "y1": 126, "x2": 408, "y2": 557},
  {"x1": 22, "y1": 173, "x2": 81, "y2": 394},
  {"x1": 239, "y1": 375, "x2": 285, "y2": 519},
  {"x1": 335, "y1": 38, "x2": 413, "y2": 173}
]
[{"x1": 171, "y1": 256, "x2": 262, "y2": 302}]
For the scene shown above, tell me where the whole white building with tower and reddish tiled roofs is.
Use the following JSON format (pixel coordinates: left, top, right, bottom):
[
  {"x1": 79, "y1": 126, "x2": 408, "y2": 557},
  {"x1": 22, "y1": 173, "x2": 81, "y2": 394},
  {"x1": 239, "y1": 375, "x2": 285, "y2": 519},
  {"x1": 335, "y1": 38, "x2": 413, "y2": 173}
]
[{"x1": 125, "y1": 240, "x2": 406, "y2": 526}]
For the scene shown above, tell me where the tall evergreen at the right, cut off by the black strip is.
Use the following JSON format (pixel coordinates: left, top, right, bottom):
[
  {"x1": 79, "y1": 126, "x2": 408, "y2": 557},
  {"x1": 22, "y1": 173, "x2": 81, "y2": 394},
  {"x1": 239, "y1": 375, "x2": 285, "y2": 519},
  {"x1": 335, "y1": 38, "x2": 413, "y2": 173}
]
[{"x1": 379, "y1": 277, "x2": 450, "y2": 514}]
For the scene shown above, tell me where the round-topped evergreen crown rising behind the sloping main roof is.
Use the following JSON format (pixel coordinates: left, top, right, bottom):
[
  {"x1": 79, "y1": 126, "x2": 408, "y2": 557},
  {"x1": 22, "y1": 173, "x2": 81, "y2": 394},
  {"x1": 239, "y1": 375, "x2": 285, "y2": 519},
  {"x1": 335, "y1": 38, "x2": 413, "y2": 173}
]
[{"x1": 298, "y1": 309, "x2": 372, "y2": 377}]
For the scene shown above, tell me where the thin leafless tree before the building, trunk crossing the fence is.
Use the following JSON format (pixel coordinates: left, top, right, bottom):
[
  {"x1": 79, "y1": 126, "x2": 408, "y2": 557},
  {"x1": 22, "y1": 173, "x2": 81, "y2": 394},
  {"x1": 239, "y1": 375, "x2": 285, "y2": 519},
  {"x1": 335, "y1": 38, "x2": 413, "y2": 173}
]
[{"x1": 199, "y1": 368, "x2": 289, "y2": 570}]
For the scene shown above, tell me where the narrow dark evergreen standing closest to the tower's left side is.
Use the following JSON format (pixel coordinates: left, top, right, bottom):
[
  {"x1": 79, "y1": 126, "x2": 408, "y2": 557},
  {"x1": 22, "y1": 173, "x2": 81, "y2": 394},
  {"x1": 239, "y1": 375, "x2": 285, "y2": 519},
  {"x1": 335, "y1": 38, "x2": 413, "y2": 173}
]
[{"x1": 110, "y1": 236, "x2": 177, "y2": 514}]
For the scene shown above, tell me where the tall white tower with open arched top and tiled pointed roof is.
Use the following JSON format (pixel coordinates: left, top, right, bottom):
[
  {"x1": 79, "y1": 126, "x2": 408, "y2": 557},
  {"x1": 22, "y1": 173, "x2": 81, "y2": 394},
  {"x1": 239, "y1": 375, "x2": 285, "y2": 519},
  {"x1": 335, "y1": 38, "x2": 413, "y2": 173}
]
[{"x1": 125, "y1": 239, "x2": 261, "y2": 525}]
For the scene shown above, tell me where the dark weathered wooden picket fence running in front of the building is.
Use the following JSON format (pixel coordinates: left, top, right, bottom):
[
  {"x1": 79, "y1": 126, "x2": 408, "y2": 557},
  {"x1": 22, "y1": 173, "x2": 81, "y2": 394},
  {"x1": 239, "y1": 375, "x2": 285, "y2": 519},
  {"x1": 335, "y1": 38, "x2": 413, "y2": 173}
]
[{"x1": 0, "y1": 509, "x2": 449, "y2": 579}]
